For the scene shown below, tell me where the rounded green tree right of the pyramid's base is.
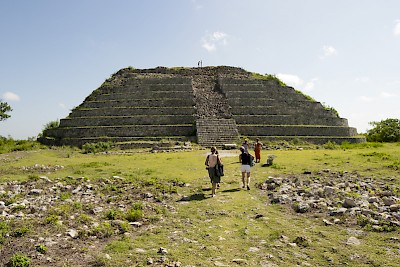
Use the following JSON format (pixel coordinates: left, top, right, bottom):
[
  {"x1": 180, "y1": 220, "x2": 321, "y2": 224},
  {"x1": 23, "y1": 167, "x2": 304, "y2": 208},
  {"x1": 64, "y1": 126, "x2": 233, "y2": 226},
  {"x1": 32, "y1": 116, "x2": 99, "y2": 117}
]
[{"x1": 367, "y1": 119, "x2": 400, "y2": 142}]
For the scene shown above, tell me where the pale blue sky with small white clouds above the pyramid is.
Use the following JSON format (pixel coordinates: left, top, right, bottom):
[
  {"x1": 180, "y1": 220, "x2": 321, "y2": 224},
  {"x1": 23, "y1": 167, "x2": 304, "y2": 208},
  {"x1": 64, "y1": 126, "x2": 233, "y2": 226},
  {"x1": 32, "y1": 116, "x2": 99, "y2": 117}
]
[{"x1": 0, "y1": 0, "x2": 400, "y2": 139}]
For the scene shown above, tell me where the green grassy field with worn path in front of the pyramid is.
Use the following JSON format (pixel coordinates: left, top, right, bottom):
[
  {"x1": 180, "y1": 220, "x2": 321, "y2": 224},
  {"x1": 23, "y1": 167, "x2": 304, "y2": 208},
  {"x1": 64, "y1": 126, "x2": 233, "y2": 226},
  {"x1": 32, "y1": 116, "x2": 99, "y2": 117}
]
[{"x1": 0, "y1": 143, "x2": 400, "y2": 267}]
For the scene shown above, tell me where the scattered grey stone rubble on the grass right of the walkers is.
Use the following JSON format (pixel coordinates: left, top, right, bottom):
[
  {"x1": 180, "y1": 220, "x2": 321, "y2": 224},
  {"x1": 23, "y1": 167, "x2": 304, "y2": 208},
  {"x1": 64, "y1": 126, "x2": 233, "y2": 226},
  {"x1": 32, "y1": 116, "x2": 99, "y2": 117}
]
[{"x1": 259, "y1": 170, "x2": 400, "y2": 231}]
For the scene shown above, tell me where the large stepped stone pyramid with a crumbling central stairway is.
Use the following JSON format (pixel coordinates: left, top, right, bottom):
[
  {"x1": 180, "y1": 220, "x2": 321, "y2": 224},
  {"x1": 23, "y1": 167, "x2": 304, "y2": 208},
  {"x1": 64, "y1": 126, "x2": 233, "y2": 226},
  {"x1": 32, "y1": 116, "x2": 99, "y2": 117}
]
[{"x1": 39, "y1": 66, "x2": 365, "y2": 147}]
